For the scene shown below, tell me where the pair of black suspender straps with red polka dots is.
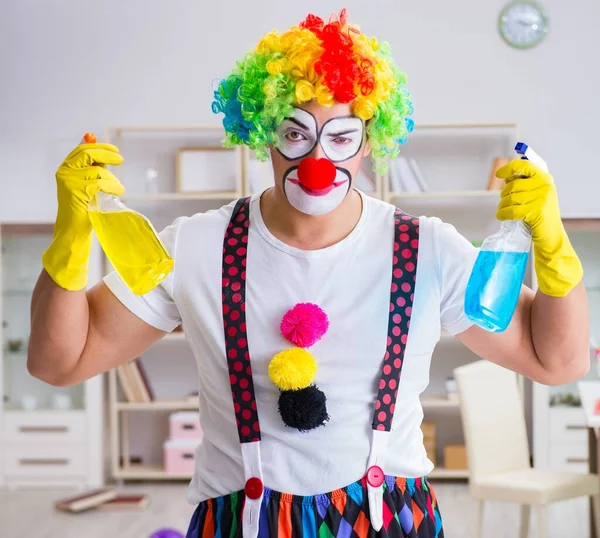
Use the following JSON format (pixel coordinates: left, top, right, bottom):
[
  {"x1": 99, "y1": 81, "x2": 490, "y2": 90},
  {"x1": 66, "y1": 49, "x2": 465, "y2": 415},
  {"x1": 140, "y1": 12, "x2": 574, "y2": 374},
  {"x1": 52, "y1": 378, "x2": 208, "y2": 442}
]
[{"x1": 223, "y1": 198, "x2": 419, "y2": 443}]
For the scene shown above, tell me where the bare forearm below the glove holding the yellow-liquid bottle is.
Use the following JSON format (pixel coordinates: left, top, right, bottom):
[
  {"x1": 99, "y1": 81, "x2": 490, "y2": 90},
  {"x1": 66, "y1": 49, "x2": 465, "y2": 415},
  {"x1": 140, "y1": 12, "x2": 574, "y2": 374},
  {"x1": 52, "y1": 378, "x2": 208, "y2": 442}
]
[{"x1": 27, "y1": 271, "x2": 89, "y2": 384}]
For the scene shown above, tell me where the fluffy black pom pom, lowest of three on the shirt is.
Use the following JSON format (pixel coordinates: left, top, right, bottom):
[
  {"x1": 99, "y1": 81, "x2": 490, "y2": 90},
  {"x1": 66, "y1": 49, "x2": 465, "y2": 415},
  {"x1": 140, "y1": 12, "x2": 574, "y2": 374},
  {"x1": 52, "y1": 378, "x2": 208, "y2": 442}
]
[{"x1": 279, "y1": 385, "x2": 329, "y2": 432}]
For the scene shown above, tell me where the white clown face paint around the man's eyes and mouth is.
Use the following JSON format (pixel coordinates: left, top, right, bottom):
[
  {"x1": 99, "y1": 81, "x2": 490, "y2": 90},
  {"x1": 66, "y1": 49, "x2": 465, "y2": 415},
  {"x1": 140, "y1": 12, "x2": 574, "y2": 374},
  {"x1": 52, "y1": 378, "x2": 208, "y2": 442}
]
[{"x1": 277, "y1": 108, "x2": 364, "y2": 216}]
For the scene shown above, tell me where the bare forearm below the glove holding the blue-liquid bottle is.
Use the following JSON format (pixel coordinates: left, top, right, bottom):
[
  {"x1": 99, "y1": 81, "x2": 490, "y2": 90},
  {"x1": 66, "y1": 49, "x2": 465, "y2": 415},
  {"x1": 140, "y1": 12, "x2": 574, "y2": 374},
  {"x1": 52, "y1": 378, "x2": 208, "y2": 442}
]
[{"x1": 531, "y1": 282, "x2": 590, "y2": 383}]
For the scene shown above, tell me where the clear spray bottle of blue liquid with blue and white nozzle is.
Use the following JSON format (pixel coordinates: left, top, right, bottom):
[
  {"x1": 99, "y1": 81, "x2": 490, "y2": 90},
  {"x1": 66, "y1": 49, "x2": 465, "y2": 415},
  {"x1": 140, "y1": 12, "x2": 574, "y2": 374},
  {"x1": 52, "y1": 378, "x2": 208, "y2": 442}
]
[{"x1": 465, "y1": 142, "x2": 548, "y2": 332}]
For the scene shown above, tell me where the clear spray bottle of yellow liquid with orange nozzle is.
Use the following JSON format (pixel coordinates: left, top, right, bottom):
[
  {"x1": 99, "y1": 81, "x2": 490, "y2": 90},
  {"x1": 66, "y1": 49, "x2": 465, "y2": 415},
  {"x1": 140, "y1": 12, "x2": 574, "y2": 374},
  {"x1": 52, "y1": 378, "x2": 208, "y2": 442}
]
[{"x1": 82, "y1": 133, "x2": 174, "y2": 295}]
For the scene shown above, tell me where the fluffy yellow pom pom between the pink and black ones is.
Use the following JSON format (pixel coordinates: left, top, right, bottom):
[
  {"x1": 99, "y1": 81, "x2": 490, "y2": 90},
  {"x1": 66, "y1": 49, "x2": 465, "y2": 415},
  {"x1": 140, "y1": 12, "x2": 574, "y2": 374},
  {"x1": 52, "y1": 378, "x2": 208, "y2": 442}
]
[{"x1": 269, "y1": 347, "x2": 317, "y2": 390}]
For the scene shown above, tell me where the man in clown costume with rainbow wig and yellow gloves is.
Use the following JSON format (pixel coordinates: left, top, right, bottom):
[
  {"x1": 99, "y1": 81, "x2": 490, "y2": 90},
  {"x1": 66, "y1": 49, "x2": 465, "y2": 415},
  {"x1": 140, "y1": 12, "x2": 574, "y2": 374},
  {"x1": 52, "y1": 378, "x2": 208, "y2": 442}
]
[{"x1": 28, "y1": 11, "x2": 589, "y2": 538}]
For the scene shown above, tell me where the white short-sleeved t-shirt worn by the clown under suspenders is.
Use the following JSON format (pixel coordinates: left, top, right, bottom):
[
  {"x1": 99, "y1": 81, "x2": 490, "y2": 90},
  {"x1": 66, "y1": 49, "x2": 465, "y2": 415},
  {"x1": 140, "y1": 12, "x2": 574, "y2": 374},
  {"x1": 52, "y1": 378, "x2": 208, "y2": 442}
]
[{"x1": 105, "y1": 189, "x2": 476, "y2": 504}]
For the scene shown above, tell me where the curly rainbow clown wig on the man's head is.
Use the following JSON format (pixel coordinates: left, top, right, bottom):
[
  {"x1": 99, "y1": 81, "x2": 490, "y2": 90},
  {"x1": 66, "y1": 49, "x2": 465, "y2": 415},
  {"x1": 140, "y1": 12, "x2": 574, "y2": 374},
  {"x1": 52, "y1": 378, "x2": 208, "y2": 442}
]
[{"x1": 212, "y1": 10, "x2": 414, "y2": 170}]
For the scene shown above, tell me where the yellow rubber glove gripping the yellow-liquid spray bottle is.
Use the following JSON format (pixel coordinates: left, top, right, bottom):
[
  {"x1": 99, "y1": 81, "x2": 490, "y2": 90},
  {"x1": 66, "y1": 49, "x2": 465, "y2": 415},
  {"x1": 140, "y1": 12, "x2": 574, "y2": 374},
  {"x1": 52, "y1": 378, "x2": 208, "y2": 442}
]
[{"x1": 42, "y1": 140, "x2": 125, "y2": 291}]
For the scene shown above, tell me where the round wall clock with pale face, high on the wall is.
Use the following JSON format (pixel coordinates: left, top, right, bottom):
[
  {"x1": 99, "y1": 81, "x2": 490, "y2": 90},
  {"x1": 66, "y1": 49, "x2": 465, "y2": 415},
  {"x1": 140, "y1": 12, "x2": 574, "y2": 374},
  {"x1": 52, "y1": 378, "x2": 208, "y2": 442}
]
[{"x1": 498, "y1": 0, "x2": 548, "y2": 49}]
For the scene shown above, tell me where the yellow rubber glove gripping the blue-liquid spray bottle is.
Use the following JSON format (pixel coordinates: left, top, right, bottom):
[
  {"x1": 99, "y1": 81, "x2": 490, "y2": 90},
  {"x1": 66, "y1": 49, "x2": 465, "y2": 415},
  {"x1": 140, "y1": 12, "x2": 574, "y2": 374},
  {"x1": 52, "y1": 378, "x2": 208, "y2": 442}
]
[{"x1": 496, "y1": 159, "x2": 583, "y2": 297}]
